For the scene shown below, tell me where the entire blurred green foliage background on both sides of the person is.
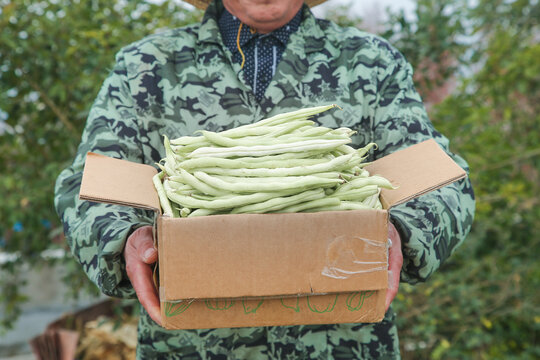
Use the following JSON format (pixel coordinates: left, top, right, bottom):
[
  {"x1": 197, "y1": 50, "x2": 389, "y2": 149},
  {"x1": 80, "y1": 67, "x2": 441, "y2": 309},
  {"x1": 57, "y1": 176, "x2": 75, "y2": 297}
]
[{"x1": 0, "y1": 0, "x2": 540, "y2": 359}]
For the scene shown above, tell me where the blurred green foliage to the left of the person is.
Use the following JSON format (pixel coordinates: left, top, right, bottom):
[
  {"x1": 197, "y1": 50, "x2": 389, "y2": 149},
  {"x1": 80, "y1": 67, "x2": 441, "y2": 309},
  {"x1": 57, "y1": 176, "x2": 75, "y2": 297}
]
[{"x1": 0, "y1": 0, "x2": 201, "y2": 329}]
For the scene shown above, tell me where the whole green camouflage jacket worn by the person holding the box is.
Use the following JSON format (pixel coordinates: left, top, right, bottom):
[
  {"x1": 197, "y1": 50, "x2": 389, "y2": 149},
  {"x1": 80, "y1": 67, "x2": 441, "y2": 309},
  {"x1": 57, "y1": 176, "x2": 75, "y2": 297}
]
[{"x1": 55, "y1": 1, "x2": 474, "y2": 359}]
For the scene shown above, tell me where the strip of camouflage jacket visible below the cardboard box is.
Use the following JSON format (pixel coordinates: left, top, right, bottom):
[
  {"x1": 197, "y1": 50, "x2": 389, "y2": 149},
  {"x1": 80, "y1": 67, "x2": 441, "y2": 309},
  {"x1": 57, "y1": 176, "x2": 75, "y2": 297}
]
[{"x1": 137, "y1": 306, "x2": 399, "y2": 360}]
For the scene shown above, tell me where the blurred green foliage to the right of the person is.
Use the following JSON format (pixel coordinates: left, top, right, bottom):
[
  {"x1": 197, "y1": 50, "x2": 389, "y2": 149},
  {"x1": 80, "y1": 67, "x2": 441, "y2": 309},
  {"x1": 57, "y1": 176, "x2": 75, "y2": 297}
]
[{"x1": 374, "y1": 0, "x2": 540, "y2": 359}]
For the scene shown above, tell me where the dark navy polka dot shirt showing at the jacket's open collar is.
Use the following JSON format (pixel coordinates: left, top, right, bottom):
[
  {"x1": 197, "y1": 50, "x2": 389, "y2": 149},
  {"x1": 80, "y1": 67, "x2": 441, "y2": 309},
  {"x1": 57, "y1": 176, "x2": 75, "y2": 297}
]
[{"x1": 219, "y1": 9, "x2": 302, "y2": 101}]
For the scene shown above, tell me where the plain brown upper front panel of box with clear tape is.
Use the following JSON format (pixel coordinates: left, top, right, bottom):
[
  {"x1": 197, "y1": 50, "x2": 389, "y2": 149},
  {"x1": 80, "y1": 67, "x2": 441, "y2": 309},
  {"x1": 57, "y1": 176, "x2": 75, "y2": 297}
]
[{"x1": 159, "y1": 210, "x2": 388, "y2": 301}]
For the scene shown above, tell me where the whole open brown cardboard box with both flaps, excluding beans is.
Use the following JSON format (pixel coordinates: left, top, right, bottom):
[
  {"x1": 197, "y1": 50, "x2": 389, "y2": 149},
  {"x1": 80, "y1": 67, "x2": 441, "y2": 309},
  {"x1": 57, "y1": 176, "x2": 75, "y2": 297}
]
[{"x1": 80, "y1": 140, "x2": 466, "y2": 329}]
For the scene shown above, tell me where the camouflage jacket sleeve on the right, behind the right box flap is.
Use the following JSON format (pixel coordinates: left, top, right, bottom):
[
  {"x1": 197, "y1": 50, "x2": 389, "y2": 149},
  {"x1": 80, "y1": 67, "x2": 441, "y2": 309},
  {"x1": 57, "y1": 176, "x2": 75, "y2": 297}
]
[{"x1": 374, "y1": 53, "x2": 475, "y2": 283}]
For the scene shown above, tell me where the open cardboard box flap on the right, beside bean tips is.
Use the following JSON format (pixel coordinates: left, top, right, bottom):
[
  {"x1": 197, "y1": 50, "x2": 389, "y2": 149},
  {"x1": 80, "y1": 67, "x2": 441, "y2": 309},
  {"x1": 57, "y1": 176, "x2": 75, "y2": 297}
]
[{"x1": 366, "y1": 139, "x2": 467, "y2": 209}]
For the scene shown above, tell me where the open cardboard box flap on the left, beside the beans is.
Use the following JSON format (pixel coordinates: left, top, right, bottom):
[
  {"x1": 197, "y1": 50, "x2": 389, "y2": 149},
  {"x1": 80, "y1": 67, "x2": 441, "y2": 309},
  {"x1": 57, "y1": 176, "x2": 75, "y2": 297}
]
[{"x1": 79, "y1": 152, "x2": 161, "y2": 212}]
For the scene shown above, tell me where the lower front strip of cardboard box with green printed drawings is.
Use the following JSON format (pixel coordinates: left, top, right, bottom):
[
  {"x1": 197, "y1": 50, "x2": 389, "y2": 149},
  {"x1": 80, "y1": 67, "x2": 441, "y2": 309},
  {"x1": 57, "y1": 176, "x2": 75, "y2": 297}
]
[{"x1": 161, "y1": 290, "x2": 386, "y2": 329}]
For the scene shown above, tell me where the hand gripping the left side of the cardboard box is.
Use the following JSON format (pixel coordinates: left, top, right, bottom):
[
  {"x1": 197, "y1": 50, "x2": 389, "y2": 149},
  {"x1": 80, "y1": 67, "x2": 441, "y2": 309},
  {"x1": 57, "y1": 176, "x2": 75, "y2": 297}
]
[{"x1": 124, "y1": 226, "x2": 161, "y2": 325}]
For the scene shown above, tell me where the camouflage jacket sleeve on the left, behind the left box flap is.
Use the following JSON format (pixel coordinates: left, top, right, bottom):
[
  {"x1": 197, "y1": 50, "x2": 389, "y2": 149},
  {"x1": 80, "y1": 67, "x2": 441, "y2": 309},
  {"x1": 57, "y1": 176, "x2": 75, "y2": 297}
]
[{"x1": 55, "y1": 53, "x2": 153, "y2": 298}]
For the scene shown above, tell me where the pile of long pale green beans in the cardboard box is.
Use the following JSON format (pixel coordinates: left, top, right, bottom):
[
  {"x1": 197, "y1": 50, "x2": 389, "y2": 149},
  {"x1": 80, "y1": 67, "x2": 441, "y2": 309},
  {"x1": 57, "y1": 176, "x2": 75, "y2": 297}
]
[{"x1": 153, "y1": 105, "x2": 392, "y2": 217}]
